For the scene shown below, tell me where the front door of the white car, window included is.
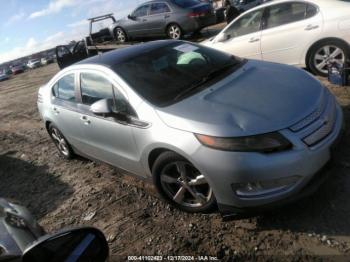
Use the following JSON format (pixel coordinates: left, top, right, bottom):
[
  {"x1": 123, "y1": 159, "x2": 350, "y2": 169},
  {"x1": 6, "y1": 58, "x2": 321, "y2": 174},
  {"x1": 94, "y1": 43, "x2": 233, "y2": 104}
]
[{"x1": 214, "y1": 9, "x2": 264, "y2": 60}]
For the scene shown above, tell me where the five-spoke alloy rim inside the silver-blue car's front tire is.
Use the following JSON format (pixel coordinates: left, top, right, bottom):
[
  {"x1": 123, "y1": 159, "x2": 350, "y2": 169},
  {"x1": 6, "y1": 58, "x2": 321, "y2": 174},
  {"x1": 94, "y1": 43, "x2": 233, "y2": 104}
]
[{"x1": 160, "y1": 161, "x2": 213, "y2": 207}]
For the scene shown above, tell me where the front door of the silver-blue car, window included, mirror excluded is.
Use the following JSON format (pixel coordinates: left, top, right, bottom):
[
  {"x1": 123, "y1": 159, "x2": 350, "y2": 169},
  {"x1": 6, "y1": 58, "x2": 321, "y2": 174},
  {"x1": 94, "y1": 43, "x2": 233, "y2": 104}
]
[{"x1": 79, "y1": 71, "x2": 141, "y2": 173}]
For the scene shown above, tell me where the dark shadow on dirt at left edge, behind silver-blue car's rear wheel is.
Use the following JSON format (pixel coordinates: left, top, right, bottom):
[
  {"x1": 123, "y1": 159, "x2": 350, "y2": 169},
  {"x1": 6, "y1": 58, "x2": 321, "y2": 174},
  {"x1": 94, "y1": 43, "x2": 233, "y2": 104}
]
[{"x1": 0, "y1": 152, "x2": 73, "y2": 219}]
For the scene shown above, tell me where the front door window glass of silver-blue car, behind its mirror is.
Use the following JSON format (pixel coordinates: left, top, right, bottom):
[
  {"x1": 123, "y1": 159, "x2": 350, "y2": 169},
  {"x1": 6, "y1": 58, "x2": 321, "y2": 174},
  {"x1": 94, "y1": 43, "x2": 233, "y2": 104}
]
[{"x1": 80, "y1": 73, "x2": 113, "y2": 105}]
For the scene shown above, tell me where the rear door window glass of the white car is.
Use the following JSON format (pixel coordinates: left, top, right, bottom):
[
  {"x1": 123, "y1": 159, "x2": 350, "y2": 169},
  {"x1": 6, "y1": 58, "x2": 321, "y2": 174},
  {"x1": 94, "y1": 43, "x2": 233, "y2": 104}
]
[{"x1": 266, "y1": 2, "x2": 307, "y2": 28}]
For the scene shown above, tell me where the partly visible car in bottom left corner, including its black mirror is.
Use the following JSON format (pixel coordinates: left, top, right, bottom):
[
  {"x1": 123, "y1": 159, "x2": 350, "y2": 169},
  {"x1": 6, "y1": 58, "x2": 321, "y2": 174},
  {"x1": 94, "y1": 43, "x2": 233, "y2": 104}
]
[{"x1": 0, "y1": 198, "x2": 109, "y2": 262}]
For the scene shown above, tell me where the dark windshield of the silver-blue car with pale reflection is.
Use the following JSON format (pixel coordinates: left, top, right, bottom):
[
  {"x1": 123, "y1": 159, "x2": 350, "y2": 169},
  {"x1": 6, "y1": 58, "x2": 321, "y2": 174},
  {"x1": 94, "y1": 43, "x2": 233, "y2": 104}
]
[{"x1": 114, "y1": 42, "x2": 241, "y2": 107}]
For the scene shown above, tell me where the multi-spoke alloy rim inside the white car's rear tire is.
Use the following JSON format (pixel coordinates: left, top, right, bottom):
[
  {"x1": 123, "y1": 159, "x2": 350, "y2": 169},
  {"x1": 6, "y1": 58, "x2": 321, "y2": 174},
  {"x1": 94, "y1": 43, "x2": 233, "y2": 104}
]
[{"x1": 313, "y1": 45, "x2": 345, "y2": 74}]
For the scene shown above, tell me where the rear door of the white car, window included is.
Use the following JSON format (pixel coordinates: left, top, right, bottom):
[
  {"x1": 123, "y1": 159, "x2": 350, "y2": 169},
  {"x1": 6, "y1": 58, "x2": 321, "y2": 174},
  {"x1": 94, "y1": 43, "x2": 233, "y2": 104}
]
[{"x1": 261, "y1": 1, "x2": 323, "y2": 65}]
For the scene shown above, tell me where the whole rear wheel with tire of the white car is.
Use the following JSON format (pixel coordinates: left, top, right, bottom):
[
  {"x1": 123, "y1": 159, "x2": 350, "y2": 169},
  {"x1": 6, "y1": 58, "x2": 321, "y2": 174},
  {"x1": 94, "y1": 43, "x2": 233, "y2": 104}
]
[{"x1": 306, "y1": 39, "x2": 350, "y2": 77}]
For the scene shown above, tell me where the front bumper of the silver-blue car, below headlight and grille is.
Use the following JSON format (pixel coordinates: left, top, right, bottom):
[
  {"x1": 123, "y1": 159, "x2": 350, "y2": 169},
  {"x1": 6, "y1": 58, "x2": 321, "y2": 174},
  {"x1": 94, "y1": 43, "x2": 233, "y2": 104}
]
[{"x1": 190, "y1": 102, "x2": 344, "y2": 218}]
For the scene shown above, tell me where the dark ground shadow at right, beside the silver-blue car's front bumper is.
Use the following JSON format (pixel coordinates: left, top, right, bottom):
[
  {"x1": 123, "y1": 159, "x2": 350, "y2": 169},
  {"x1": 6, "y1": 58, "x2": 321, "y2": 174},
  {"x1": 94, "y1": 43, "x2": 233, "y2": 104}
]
[{"x1": 257, "y1": 104, "x2": 350, "y2": 236}]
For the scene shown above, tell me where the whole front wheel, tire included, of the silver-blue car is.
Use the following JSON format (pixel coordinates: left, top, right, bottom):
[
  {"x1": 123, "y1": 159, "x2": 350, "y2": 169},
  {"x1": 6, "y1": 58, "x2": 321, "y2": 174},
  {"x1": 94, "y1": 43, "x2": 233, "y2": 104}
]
[{"x1": 152, "y1": 152, "x2": 216, "y2": 213}]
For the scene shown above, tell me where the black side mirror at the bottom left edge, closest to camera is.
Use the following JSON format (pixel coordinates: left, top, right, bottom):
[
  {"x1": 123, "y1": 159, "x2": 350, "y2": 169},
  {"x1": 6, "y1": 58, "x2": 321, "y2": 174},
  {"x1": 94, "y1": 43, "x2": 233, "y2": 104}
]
[{"x1": 22, "y1": 227, "x2": 109, "y2": 262}]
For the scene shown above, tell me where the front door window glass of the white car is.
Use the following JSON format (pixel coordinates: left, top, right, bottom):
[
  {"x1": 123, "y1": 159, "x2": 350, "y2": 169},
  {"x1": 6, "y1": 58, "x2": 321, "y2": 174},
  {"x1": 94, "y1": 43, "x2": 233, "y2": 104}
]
[{"x1": 225, "y1": 10, "x2": 264, "y2": 37}]
